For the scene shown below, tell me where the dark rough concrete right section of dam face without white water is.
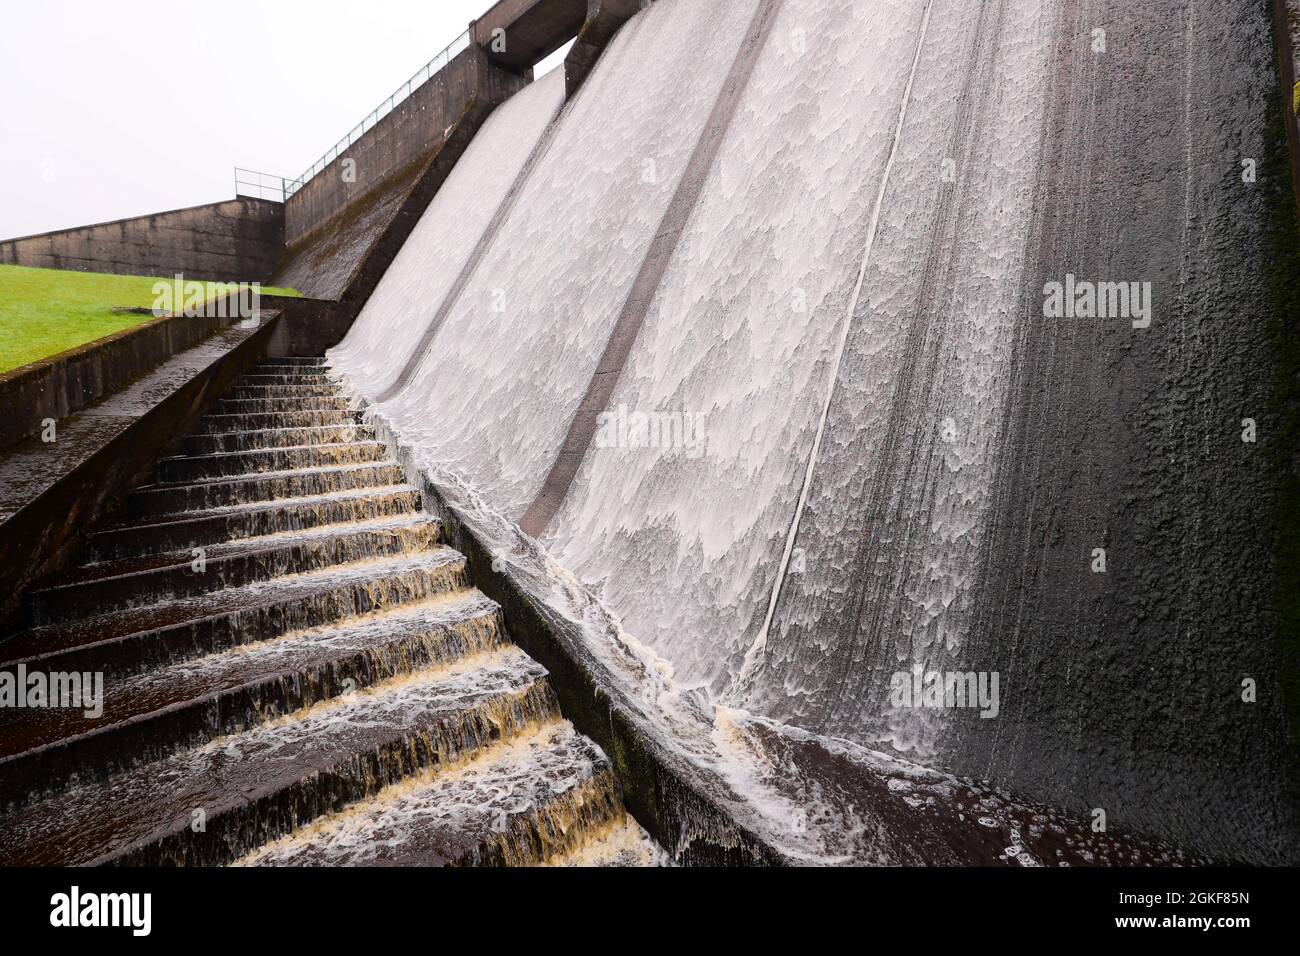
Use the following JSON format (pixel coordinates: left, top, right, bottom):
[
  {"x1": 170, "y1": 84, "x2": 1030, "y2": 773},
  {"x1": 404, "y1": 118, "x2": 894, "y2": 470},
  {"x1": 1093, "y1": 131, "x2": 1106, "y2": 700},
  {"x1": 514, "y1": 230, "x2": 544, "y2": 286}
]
[{"x1": 949, "y1": 0, "x2": 1300, "y2": 862}]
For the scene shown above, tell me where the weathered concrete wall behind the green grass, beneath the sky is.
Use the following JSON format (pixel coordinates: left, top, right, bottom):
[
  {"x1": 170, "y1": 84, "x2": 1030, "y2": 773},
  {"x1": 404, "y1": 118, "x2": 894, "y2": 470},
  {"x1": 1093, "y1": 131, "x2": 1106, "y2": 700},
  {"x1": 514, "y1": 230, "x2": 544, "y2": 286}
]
[{"x1": 0, "y1": 196, "x2": 285, "y2": 282}]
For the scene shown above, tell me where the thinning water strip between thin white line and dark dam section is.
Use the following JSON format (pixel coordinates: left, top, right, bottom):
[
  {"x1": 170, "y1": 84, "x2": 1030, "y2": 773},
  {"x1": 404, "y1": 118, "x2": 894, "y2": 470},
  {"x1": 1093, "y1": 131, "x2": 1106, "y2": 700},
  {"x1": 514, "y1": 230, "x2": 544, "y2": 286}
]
[{"x1": 745, "y1": 0, "x2": 1052, "y2": 756}]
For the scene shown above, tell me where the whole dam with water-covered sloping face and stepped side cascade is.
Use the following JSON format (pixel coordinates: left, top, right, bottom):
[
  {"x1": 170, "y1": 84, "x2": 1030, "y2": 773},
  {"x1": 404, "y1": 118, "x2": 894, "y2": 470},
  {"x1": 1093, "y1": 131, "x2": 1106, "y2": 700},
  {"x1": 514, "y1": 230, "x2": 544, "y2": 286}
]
[{"x1": 0, "y1": 0, "x2": 1300, "y2": 866}]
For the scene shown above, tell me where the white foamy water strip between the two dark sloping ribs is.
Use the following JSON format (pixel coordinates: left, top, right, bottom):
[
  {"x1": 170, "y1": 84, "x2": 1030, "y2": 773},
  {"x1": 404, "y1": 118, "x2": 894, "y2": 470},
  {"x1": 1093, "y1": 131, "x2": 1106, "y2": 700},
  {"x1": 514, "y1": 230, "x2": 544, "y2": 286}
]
[{"x1": 335, "y1": 0, "x2": 757, "y2": 518}]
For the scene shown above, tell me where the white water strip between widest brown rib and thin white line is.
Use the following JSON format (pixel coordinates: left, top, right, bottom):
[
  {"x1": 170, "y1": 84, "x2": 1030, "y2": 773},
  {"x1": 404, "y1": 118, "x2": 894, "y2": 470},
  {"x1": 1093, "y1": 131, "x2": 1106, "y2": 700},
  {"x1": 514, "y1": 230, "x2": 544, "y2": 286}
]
[{"x1": 540, "y1": 0, "x2": 926, "y2": 702}]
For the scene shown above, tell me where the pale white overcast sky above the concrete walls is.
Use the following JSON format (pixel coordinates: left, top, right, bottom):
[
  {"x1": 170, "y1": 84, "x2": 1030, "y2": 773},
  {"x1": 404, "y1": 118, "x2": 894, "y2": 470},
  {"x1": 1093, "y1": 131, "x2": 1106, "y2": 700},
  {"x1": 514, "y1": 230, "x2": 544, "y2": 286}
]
[{"x1": 0, "y1": 0, "x2": 559, "y2": 238}]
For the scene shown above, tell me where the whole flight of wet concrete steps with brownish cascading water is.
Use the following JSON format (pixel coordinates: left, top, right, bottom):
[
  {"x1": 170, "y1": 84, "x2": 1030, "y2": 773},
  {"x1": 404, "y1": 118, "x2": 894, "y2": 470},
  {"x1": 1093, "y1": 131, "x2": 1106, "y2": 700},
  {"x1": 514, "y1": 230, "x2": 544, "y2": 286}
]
[{"x1": 0, "y1": 359, "x2": 662, "y2": 865}]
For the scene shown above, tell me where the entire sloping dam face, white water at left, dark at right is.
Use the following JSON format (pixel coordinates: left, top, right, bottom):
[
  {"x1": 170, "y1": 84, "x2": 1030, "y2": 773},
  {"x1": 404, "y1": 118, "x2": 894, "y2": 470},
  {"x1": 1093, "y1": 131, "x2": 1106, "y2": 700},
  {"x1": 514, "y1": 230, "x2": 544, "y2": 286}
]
[{"x1": 329, "y1": 0, "x2": 1300, "y2": 862}]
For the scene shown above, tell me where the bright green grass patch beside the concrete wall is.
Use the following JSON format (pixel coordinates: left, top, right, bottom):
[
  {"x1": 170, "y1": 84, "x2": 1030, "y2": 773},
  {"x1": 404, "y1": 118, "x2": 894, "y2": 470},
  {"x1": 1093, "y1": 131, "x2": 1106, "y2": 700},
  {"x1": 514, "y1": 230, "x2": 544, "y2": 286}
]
[{"x1": 0, "y1": 265, "x2": 298, "y2": 375}]
